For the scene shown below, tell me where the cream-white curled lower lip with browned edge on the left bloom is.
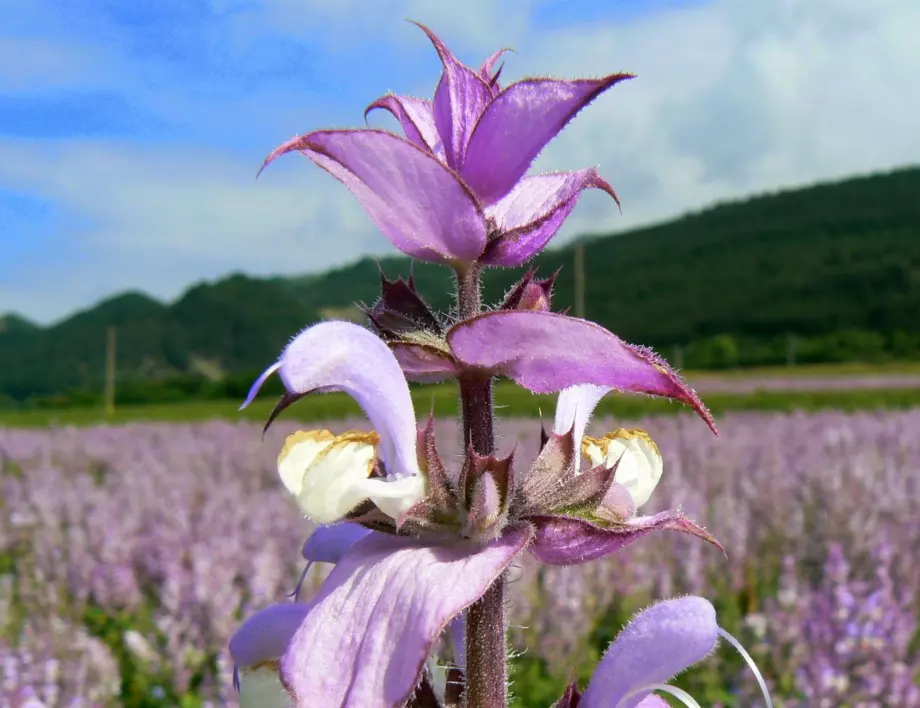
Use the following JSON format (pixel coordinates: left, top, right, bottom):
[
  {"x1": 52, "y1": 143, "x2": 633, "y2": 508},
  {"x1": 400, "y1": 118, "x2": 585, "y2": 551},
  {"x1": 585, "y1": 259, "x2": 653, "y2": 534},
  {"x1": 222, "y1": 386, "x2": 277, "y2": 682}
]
[{"x1": 278, "y1": 430, "x2": 427, "y2": 524}]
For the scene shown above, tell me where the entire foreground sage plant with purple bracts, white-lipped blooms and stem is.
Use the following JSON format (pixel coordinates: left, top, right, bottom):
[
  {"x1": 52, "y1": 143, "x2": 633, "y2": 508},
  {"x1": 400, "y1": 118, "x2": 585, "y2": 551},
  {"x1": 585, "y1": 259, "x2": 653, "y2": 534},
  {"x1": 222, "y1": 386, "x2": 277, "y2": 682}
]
[{"x1": 230, "y1": 22, "x2": 769, "y2": 708}]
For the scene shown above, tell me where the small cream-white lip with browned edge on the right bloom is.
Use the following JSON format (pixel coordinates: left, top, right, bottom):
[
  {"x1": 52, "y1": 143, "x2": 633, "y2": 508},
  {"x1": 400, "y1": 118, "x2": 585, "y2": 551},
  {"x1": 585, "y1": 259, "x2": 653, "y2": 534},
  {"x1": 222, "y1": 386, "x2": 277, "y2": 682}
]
[{"x1": 582, "y1": 428, "x2": 664, "y2": 509}]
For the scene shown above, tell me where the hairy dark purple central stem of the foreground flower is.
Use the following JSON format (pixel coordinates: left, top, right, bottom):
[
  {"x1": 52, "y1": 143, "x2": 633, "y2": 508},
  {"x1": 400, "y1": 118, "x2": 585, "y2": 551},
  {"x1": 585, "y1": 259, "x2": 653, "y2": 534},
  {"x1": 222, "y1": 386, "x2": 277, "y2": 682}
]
[{"x1": 457, "y1": 265, "x2": 508, "y2": 708}]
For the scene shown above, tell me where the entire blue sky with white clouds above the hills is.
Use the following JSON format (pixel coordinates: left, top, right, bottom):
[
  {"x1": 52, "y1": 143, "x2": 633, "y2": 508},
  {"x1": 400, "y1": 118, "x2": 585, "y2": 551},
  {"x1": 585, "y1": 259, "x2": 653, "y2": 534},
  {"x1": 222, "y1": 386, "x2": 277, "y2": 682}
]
[{"x1": 0, "y1": 0, "x2": 920, "y2": 323}]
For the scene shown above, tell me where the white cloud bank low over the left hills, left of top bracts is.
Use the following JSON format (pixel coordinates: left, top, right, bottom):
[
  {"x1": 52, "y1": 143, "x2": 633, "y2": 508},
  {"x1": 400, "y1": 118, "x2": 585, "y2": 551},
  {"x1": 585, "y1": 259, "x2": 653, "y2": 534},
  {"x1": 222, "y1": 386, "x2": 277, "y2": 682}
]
[{"x1": 0, "y1": 141, "x2": 400, "y2": 321}]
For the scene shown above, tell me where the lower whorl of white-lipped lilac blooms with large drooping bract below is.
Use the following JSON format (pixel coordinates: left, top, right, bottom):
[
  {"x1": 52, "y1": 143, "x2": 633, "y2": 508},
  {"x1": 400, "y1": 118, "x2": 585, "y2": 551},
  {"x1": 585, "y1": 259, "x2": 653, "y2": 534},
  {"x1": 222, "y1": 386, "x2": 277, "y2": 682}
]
[{"x1": 234, "y1": 322, "x2": 718, "y2": 708}]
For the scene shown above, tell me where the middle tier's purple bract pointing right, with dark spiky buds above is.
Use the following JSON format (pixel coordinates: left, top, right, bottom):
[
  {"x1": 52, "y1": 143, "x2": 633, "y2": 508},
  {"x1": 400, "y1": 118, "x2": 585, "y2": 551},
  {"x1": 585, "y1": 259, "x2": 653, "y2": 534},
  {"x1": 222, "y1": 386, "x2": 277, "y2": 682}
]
[{"x1": 366, "y1": 280, "x2": 715, "y2": 432}]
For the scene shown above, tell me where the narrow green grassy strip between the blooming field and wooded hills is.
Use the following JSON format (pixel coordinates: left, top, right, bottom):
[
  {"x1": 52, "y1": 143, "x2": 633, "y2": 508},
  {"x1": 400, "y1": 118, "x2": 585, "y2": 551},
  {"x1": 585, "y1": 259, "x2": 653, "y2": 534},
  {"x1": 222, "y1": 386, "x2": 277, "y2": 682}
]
[{"x1": 0, "y1": 362, "x2": 920, "y2": 427}]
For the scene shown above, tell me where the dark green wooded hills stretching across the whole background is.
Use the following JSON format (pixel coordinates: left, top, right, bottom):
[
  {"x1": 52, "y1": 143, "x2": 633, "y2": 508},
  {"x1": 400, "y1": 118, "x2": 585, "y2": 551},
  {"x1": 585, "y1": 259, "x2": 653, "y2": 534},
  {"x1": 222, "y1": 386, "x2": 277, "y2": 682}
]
[{"x1": 0, "y1": 162, "x2": 920, "y2": 399}]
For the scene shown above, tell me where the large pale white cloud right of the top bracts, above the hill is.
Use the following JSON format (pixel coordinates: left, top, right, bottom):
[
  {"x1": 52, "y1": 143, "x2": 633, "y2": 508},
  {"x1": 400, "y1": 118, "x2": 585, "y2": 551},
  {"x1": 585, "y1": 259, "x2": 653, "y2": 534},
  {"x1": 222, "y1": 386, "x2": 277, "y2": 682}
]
[{"x1": 511, "y1": 0, "x2": 920, "y2": 234}]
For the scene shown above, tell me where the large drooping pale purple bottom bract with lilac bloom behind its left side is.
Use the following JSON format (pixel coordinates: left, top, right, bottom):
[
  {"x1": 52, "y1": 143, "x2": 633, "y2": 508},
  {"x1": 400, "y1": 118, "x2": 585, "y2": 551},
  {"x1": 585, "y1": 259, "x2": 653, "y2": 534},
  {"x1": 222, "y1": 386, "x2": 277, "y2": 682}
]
[{"x1": 230, "y1": 527, "x2": 532, "y2": 708}]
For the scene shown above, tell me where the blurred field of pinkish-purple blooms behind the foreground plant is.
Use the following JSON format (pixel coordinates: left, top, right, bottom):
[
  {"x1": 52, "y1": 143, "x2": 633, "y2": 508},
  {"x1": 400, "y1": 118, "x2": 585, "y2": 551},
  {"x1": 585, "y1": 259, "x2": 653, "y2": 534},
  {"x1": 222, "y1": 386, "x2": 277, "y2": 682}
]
[{"x1": 0, "y1": 410, "x2": 920, "y2": 706}]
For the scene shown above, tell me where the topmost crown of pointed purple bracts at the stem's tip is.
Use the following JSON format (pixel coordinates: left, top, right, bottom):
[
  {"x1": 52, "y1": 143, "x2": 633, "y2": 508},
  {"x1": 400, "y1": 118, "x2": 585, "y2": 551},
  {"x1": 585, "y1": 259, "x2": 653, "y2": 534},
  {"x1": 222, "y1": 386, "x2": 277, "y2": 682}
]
[{"x1": 263, "y1": 25, "x2": 632, "y2": 266}]
